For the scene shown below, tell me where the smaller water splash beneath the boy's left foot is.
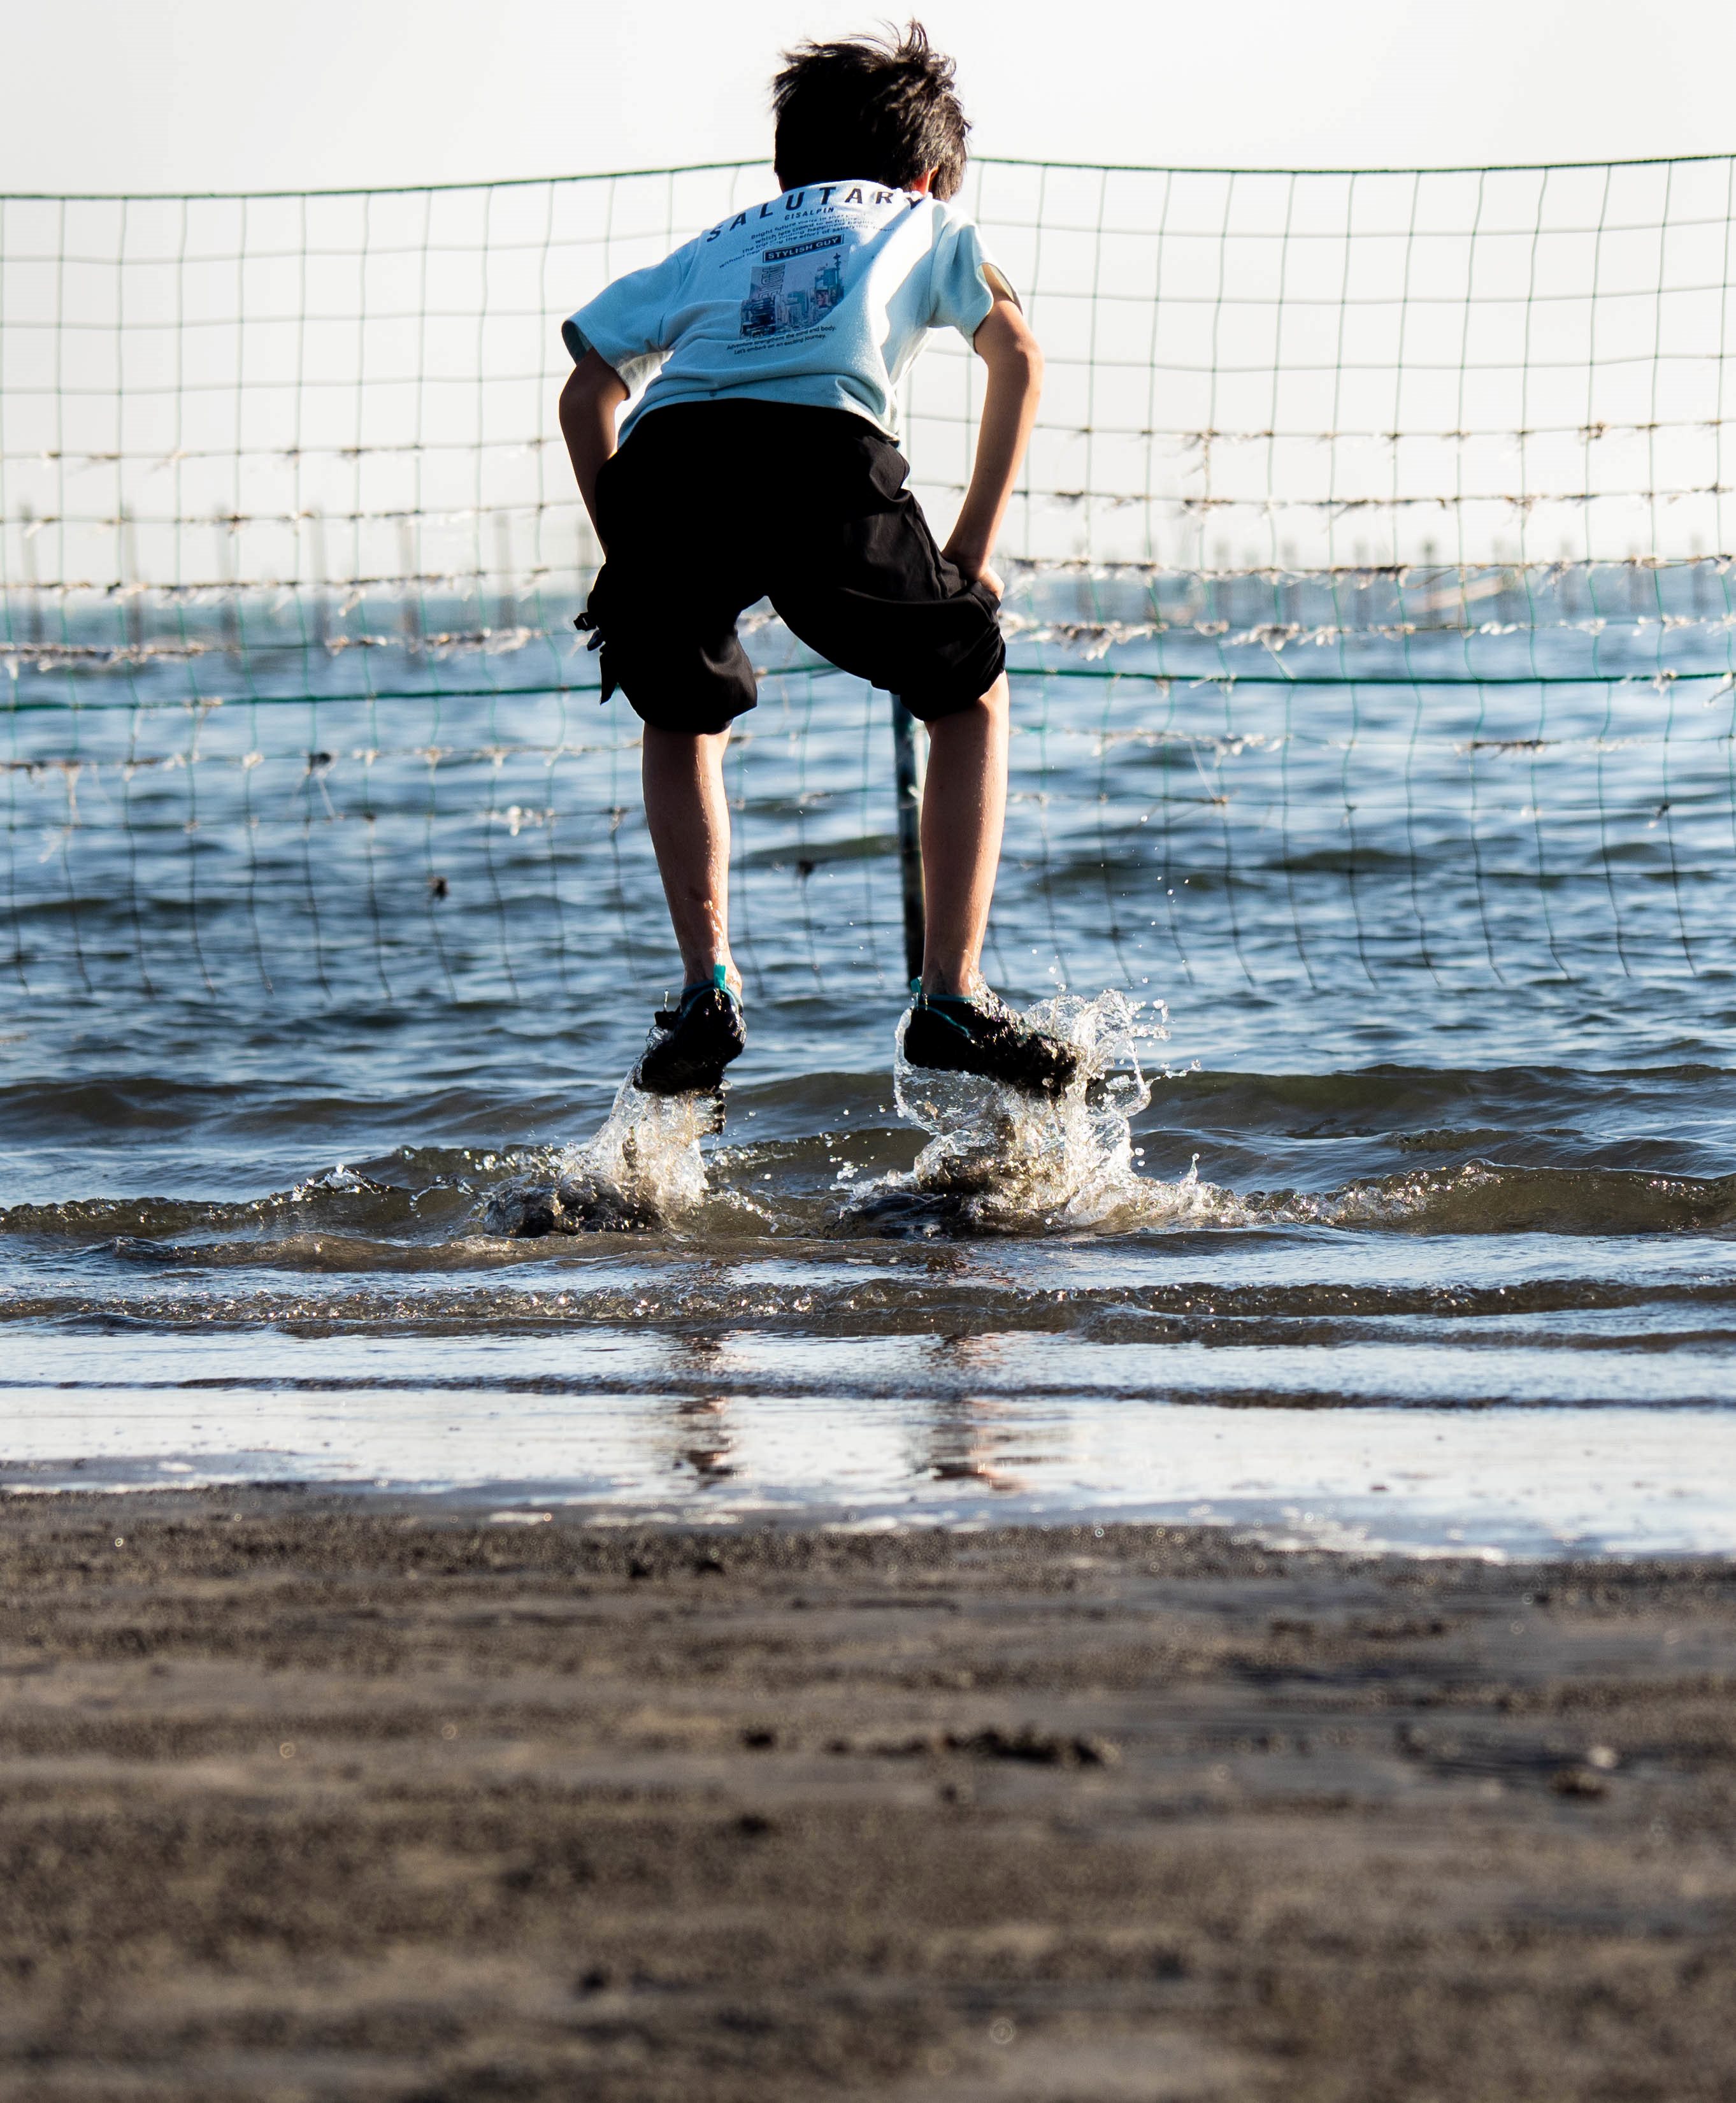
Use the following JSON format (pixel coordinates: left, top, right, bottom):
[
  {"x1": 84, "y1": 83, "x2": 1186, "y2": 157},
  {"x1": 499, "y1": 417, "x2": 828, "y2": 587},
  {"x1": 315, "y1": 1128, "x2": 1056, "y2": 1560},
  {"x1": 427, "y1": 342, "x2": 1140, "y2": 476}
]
[{"x1": 484, "y1": 1079, "x2": 721, "y2": 1238}]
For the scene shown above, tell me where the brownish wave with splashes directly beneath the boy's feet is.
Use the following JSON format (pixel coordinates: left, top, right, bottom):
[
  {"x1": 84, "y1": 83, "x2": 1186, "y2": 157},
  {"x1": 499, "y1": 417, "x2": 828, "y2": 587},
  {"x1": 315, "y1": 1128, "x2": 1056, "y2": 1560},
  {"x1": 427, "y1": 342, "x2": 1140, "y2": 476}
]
[{"x1": 13, "y1": 1059, "x2": 1736, "y2": 1253}]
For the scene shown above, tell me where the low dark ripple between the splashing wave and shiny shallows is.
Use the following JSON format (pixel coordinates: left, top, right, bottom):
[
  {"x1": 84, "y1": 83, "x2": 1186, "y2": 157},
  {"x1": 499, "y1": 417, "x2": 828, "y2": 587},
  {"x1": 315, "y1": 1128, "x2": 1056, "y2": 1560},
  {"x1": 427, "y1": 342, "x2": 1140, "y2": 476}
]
[{"x1": 0, "y1": 1247, "x2": 1736, "y2": 1337}]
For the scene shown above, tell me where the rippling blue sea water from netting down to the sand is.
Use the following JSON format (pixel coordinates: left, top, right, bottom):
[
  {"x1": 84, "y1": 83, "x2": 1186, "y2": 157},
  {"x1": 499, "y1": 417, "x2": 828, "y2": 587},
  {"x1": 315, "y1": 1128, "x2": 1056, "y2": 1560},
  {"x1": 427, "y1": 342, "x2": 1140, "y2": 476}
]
[{"x1": 0, "y1": 601, "x2": 1736, "y2": 1552}]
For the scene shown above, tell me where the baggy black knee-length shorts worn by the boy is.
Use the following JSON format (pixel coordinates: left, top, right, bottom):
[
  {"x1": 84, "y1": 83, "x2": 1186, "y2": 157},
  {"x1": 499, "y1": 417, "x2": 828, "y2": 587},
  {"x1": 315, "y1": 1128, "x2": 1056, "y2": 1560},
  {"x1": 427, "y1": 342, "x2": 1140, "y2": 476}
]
[{"x1": 582, "y1": 399, "x2": 1007, "y2": 732}]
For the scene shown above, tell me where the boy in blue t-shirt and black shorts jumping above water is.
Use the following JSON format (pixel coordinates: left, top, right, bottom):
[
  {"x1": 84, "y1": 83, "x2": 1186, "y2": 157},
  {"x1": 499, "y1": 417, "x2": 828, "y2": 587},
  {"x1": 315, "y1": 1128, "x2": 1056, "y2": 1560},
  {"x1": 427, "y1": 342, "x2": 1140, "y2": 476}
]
[{"x1": 561, "y1": 23, "x2": 1078, "y2": 1096}]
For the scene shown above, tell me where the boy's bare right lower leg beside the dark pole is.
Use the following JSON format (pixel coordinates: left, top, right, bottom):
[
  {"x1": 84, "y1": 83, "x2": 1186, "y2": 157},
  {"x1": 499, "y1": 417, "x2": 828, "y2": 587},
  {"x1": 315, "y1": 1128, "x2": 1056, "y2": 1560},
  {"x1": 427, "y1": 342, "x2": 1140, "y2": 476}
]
[{"x1": 922, "y1": 673, "x2": 1009, "y2": 993}]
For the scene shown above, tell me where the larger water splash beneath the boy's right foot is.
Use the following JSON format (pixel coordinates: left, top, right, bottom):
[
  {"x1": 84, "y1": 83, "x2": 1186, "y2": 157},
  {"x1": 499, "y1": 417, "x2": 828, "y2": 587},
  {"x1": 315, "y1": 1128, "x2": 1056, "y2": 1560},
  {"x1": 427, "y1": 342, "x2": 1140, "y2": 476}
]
[{"x1": 838, "y1": 993, "x2": 1234, "y2": 1237}]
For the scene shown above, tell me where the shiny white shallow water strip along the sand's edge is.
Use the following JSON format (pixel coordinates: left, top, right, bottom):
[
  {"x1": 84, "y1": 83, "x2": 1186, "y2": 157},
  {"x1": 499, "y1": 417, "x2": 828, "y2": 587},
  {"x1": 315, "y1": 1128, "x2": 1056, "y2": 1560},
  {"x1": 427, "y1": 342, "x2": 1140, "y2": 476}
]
[{"x1": 0, "y1": 1379, "x2": 1736, "y2": 1560}]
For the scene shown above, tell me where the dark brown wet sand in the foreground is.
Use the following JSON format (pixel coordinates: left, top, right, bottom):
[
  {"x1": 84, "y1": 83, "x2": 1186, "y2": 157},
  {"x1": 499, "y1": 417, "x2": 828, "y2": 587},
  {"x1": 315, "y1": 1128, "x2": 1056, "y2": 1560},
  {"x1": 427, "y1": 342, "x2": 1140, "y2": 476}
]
[{"x1": 0, "y1": 1491, "x2": 1736, "y2": 2103}]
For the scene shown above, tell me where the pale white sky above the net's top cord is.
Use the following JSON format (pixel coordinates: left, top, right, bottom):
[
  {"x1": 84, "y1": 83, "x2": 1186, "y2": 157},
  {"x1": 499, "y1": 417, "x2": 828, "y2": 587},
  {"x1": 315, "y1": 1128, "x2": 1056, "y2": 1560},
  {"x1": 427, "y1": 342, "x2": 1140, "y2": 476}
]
[{"x1": 0, "y1": 0, "x2": 1736, "y2": 191}]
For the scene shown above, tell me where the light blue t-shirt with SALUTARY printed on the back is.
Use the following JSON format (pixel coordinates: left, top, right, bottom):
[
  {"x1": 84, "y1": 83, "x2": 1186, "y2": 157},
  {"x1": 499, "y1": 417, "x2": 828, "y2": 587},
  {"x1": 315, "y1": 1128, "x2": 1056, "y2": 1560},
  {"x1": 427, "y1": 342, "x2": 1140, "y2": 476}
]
[{"x1": 561, "y1": 183, "x2": 1011, "y2": 438}]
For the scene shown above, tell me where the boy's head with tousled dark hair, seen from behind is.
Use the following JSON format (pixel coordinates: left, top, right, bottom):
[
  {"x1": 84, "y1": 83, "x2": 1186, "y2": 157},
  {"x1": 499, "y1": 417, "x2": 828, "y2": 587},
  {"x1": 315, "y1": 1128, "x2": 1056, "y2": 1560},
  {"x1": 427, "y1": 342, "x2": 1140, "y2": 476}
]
[{"x1": 771, "y1": 21, "x2": 971, "y2": 197}]
